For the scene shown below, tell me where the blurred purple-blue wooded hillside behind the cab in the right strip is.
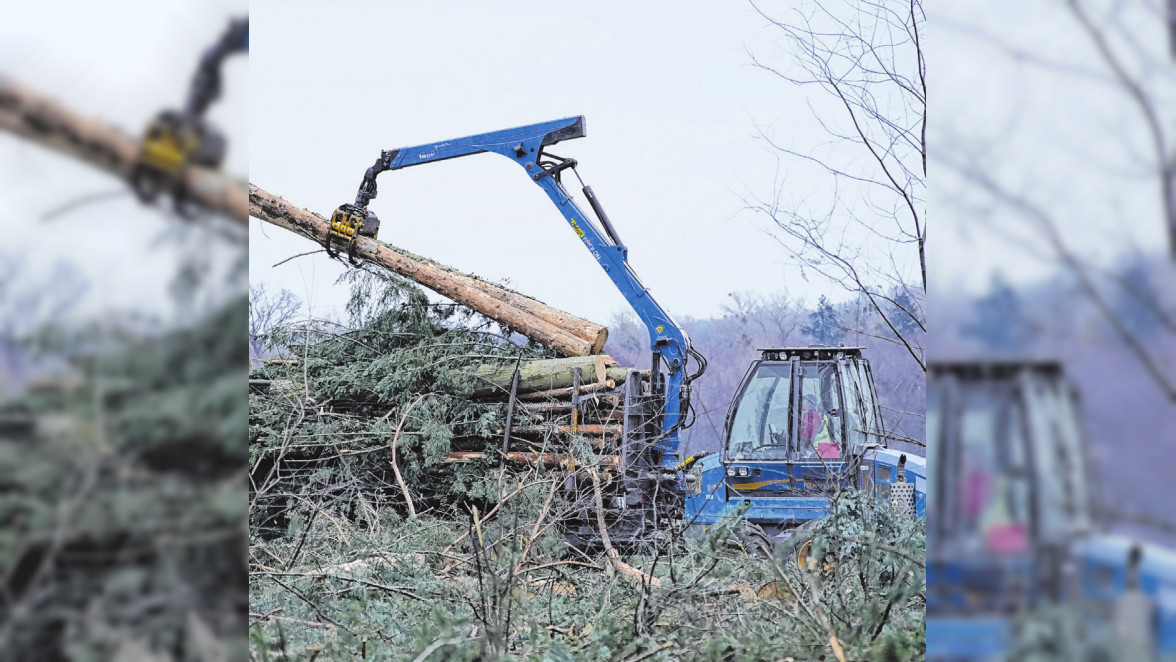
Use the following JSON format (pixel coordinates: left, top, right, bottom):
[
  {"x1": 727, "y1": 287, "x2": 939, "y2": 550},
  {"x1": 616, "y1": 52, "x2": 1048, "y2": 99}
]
[{"x1": 930, "y1": 252, "x2": 1176, "y2": 541}]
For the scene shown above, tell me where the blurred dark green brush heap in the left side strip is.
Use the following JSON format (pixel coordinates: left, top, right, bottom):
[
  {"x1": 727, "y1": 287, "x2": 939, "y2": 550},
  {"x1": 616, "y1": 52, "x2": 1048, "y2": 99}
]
[{"x1": 0, "y1": 296, "x2": 248, "y2": 660}]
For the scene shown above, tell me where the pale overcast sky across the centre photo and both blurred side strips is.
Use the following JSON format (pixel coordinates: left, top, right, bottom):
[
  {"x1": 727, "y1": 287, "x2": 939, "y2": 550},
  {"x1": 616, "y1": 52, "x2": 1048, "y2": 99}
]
[{"x1": 0, "y1": 0, "x2": 1157, "y2": 322}]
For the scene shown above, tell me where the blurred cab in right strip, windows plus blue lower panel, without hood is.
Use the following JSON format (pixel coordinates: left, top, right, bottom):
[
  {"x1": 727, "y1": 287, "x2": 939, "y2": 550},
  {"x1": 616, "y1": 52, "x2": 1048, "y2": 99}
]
[{"x1": 927, "y1": 361, "x2": 1091, "y2": 615}]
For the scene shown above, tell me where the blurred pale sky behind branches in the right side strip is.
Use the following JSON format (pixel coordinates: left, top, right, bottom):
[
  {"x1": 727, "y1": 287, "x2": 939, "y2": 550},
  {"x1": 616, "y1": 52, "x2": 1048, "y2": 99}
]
[{"x1": 928, "y1": 0, "x2": 1176, "y2": 296}]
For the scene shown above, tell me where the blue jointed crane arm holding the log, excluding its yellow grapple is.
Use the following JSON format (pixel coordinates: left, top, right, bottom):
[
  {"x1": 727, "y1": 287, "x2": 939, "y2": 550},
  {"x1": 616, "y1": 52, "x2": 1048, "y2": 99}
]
[{"x1": 355, "y1": 115, "x2": 699, "y2": 472}]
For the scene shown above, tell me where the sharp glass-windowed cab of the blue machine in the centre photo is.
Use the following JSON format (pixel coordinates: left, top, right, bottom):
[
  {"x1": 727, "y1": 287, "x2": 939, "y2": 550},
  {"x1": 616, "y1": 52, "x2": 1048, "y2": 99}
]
[{"x1": 723, "y1": 346, "x2": 884, "y2": 487}]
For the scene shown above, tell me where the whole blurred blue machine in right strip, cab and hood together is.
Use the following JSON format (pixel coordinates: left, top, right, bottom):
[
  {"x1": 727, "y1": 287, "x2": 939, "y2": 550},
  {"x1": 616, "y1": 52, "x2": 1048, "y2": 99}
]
[{"x1": 927, "y1": 360, "x2": 1176, "y2": 661}]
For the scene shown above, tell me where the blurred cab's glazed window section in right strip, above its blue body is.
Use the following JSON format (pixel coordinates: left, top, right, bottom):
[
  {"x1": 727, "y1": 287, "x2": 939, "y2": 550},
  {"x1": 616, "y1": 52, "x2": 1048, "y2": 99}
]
[{"x1": 927, "y1": 361, "x2": 1091, "y2": 564}]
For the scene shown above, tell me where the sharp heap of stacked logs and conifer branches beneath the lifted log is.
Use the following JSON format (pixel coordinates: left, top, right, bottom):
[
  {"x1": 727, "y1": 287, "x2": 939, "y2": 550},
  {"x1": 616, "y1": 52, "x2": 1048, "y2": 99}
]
[{"x1": 249, "y1": 269, "x2": 647, "y2": 535}]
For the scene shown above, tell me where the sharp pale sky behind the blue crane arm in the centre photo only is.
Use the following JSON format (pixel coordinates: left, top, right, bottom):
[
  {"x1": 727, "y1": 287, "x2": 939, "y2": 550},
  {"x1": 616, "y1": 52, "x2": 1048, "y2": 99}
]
[{"x1": 249, "y1": 0, "x2": 884, "y2": 322}]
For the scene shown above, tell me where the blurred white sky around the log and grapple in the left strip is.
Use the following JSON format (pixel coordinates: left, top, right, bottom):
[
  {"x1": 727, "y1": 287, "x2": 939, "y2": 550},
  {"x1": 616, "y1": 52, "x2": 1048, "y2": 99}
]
[{"x1": 0, "y1": 0, "x2": 248, "y2": 322}]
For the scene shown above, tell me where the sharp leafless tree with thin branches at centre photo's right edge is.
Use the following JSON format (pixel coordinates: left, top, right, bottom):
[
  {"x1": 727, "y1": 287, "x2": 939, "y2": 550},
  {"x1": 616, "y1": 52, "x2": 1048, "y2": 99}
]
[{"x1": 750, "y1": 0, "x2": 927, "y2": 370}]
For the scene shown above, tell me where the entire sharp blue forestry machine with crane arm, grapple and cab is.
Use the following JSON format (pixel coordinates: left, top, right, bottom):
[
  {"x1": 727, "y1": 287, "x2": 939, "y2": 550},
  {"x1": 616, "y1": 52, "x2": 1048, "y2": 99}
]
[{"x1": 326, "y1": 115, "x2": 927, "y2": 543}]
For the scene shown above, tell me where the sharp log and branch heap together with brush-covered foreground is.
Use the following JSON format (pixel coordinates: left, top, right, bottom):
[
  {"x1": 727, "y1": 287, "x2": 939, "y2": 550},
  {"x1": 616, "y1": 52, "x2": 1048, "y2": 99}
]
[{"x1": 249, "y1": 269, "x2": 924, "y2": 661}]
